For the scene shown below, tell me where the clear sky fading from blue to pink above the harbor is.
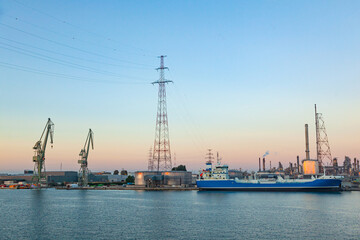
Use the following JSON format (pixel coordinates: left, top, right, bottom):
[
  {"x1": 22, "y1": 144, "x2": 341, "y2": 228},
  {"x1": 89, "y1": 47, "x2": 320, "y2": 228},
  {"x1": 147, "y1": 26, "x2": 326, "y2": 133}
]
[{"x1": 0, "y1": 0, "x2": 360, "y2": 173}]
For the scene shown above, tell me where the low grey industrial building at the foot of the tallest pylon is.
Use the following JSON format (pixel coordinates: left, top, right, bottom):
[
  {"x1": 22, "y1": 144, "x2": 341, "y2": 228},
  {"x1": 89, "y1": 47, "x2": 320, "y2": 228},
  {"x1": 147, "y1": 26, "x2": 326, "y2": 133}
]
[{"x1": 135, "y1": 171, "x2": 193, "y2": 187}]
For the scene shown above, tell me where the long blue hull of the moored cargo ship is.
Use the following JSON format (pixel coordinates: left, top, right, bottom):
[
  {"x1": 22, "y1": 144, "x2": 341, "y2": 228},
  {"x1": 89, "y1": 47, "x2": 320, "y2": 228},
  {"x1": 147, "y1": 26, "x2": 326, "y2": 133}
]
[{"x1": 196, "y1": 179, "x2": 341, "y2": 191}]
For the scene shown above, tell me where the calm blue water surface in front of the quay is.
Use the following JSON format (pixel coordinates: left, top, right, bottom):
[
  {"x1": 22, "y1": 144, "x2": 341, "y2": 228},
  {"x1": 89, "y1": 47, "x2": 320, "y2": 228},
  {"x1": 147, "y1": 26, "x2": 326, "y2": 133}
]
[{"x1": 0, "y1": 189, "x2": 360, "y2": 239}]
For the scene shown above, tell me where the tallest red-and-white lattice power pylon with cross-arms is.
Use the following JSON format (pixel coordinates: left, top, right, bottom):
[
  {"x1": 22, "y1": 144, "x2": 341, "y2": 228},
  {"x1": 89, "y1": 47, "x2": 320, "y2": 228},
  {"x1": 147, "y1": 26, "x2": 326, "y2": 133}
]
[{"x1": 152, "y1": 55, "x2": 172, "y2": 171}]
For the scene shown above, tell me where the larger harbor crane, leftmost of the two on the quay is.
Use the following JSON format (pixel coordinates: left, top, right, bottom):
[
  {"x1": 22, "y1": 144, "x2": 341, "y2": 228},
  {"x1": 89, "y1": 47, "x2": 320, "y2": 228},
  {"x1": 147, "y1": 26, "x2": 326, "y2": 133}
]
[{"x1": 32, "y1": 118, "x2": 54, "y2": 187}]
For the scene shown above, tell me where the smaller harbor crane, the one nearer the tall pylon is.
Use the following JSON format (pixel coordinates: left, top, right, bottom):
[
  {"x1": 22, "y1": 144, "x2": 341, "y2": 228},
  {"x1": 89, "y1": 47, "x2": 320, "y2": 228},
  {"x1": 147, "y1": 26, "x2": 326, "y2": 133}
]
[{"x1": 78, "y1": 129, "x2": 94, "y2": 187}]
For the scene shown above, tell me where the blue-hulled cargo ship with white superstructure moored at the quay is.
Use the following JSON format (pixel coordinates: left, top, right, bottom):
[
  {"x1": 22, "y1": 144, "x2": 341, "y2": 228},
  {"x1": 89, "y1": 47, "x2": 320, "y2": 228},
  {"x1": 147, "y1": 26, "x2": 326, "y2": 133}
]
[{"x1": 196, "y1": 159, "x2": 341, "y2": 191}]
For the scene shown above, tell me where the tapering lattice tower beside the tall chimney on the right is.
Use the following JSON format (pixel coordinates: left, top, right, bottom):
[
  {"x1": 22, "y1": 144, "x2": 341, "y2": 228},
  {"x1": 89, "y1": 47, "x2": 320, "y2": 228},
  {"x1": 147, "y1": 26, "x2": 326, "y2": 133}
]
[{"x1": 315, "y1": 104, "x2": 333, "y2": 166}]
